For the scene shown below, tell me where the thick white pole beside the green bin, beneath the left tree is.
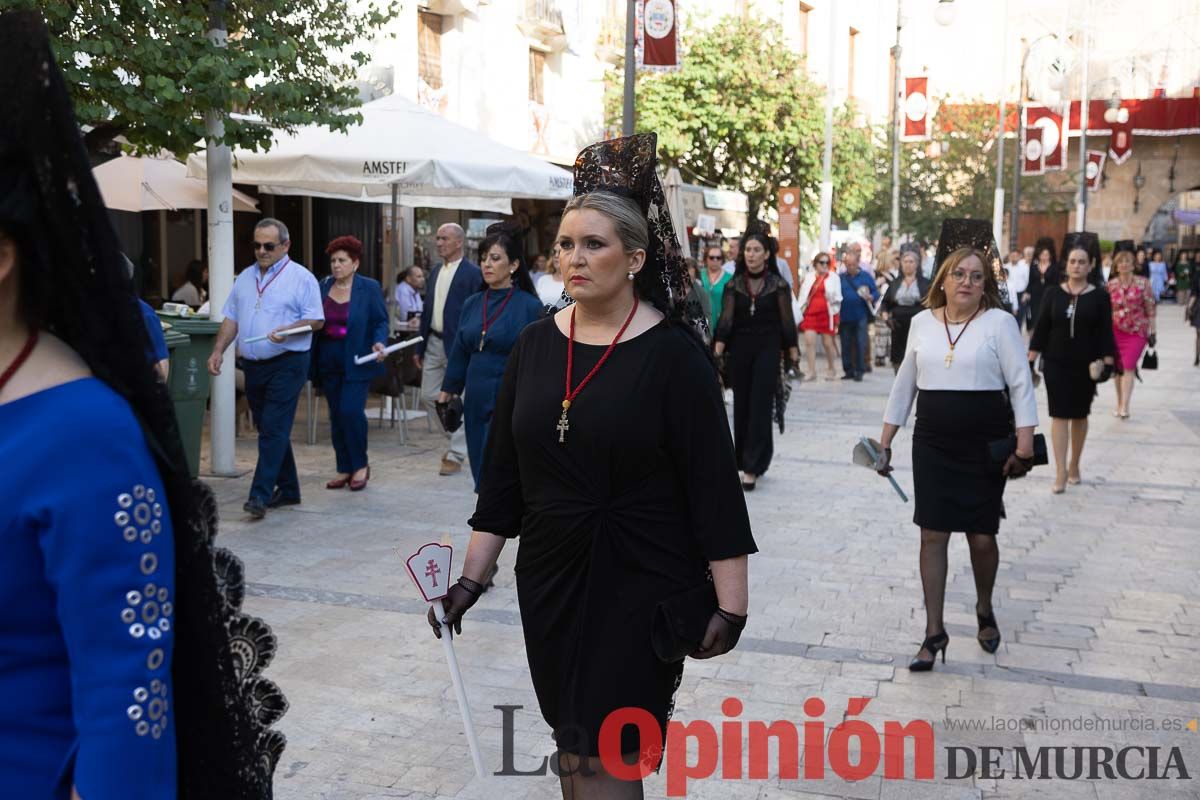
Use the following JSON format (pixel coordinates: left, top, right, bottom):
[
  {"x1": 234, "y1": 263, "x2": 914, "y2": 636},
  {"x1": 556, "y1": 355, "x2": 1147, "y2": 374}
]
[{"x1": 204, "y1": 0, "x2": 238, "y2": 476}]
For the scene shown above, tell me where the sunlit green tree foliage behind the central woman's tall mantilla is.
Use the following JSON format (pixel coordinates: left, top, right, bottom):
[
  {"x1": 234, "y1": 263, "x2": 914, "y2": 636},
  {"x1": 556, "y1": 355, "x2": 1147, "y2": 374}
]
[{"x1": 607, "y1": 16, "x2": 876, "y2": 227}]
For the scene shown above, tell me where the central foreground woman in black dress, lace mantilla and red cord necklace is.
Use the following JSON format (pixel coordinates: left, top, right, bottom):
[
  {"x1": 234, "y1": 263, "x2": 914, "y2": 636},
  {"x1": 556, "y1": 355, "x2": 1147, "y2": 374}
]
[{"x1": 430, "y1": 134, "x2": 756, "y2": 799}]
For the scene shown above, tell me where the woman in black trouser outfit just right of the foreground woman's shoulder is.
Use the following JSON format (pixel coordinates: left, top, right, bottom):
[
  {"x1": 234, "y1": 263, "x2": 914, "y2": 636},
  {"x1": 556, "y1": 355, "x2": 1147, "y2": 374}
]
[{"x1": 713, "y1": 225, "x2": 800, "y2": 492}]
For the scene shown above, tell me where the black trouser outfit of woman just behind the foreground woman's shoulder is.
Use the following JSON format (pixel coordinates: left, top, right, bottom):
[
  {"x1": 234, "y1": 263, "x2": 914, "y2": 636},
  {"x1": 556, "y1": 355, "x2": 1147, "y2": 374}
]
[{"x1": 716, "y1": 272, "x2": 797, "y2": 475}]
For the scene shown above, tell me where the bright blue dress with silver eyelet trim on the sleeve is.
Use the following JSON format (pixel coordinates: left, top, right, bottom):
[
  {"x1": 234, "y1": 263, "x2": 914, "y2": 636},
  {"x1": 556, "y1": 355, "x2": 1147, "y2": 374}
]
[{"x1": 0, "y1": 378, "x2": 176, "y2": 800}]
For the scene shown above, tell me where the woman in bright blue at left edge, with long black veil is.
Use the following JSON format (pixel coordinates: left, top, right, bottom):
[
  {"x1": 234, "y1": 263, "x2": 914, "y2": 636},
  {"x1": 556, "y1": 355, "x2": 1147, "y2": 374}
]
[{"x1": 0, "y1": 13, "x2": 287, "y2": 800}]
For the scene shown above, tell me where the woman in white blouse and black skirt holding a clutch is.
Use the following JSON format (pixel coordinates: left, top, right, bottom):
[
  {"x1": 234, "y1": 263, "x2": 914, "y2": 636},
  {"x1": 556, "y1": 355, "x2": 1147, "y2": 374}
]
[{"x1": 876, "y1": 242, "x2": 1038, "y2": 672}]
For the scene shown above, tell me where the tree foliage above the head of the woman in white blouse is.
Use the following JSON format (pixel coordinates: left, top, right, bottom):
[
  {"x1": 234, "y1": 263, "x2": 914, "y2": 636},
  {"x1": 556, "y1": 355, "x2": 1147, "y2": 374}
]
[{"x1": 863, "y1": 101, "x2": 1062, "y2": 241}]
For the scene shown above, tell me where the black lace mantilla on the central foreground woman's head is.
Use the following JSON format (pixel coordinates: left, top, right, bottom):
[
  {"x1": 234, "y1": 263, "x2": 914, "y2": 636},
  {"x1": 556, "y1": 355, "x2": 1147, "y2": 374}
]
[{"x1": 559, "y1": 133, "x2": 708, "y2": 342}]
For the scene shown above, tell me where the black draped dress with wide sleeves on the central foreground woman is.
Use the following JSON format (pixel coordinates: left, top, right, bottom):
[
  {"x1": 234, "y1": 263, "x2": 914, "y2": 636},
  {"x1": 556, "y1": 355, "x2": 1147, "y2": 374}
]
[{"x1": 470, "y1": 318, "x2": 756, "y2": 756}]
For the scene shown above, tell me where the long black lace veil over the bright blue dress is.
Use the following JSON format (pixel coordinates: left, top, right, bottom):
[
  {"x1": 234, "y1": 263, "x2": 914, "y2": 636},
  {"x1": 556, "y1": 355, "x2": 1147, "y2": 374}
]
[{"x1": 0, "y1": 12, "x2": 287, "y2": 800}]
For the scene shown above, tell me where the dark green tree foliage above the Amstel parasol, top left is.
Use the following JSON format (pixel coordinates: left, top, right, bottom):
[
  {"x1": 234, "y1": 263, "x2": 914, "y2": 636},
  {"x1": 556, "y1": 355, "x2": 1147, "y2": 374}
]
[{"x1": 0, "y1": 0, "x2": 400, "y2": 156}]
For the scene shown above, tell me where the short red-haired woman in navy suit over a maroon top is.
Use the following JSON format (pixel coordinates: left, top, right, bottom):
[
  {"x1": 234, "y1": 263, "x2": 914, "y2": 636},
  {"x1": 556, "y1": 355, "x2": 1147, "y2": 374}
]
[{"x1": 312, "y1": 236, "x2": 388, "y2": 492}]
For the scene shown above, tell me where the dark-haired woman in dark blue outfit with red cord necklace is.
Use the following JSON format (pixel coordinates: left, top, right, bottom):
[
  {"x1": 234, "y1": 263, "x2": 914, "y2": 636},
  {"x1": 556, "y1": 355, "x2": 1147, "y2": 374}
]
[{"x1": 438, "y1": 222, "x2": 545, "y2": 492}]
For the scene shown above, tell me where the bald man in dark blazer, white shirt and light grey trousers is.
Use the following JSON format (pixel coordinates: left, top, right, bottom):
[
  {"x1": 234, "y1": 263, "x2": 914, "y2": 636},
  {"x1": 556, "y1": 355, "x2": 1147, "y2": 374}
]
[{"x1": 415, "y1": 223, "x2": 484, "y2": 475}]
